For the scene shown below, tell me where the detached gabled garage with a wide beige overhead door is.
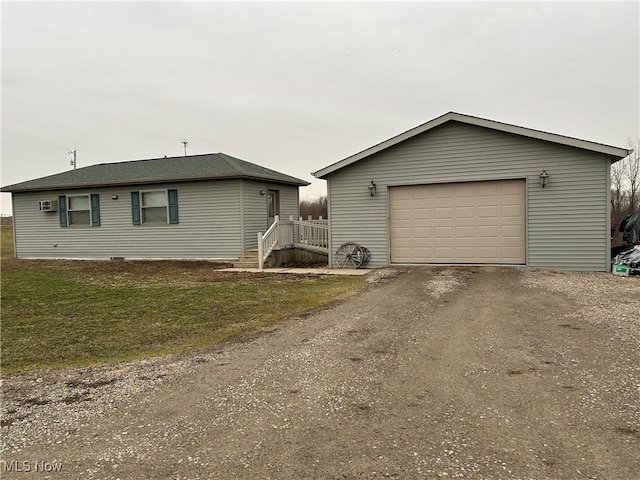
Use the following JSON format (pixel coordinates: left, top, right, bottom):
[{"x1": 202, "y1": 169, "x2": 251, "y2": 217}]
[{"x1": 314, "y1": 112, "x2": 630, "y2": 271}]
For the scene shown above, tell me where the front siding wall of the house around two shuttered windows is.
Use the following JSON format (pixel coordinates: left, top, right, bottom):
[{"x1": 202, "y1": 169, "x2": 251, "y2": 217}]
[{"x1": 13, "y1": 180, "x2": 243, "y2": 259}]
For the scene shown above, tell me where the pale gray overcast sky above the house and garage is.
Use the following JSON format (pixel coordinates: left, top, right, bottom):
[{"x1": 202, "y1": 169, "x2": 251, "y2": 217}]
[{"x1": 1, "y1": 2, "x2": 640, "y2": 213}]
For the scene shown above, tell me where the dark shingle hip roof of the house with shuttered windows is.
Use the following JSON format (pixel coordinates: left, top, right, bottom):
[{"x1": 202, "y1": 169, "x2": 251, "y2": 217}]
[{"x1": 2, "y1": 153, "x2": 309, "y2": 192}]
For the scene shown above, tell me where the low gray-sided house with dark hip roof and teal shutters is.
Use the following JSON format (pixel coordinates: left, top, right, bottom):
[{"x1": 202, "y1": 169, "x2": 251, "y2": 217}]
[{"x1": 2, "y1": 153, "x2": 308, "y2": 260}]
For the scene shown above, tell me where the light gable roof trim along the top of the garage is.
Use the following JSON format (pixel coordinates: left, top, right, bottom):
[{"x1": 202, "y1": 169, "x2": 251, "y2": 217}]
[{"x1": 312, "y1": 112, "x2": 631, "y2": 178}]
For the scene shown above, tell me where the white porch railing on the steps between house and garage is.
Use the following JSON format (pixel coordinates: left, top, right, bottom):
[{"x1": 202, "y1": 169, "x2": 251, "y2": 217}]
[{"x1": 258, "y1": 215, "x2": 329, "y2": 270}]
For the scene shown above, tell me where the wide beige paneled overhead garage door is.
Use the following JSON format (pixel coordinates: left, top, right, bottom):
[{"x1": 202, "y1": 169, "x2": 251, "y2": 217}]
[{"x1": 389, "y1": 180, "x2": 526, "y2": 264}]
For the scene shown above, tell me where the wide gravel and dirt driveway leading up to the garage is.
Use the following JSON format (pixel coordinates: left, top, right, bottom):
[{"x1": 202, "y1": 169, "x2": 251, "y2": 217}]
[{"x1": 1, "y1": 267, "x2": 640, "y2": 480}]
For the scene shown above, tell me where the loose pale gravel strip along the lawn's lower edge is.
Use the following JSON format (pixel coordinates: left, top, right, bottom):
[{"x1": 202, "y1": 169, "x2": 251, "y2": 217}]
[{"x1": 0, "y1": 354, "x2": 217, "y2": 454}]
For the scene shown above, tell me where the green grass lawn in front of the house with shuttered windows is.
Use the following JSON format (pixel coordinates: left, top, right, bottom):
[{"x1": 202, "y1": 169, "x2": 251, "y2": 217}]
[{"x1": 1, "y1": 227, "x2": 364, "y2": 373}]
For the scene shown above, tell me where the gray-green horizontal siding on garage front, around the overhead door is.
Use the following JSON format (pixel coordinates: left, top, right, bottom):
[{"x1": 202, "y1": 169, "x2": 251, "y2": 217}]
[{"x1": 327, "y1": 122, "x2": 611, "y2": 271}]
